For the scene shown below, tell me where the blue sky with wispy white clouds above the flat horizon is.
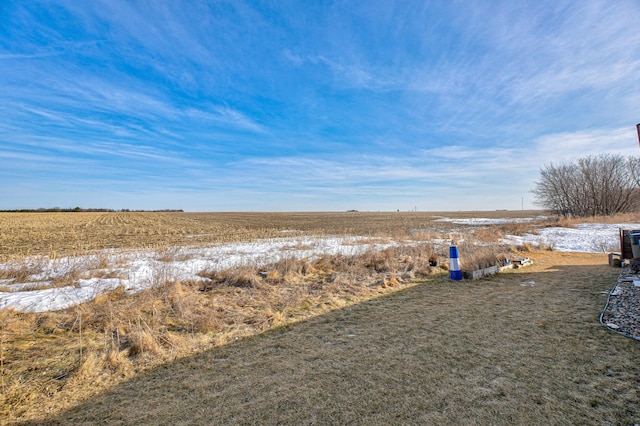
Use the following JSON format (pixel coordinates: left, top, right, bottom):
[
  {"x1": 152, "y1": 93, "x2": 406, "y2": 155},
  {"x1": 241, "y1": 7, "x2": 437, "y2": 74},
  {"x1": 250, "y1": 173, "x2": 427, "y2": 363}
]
[{"x1": 0, "y1": 0, "x2": 640, "y2": 211}]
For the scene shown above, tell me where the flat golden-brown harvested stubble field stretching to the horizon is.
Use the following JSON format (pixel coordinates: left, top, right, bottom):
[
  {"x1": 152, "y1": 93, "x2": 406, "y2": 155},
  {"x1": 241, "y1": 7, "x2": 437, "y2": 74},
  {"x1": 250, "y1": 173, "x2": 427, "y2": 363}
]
[{"x1": 0, "y1": 211, "x2": 540, "y2": 260}]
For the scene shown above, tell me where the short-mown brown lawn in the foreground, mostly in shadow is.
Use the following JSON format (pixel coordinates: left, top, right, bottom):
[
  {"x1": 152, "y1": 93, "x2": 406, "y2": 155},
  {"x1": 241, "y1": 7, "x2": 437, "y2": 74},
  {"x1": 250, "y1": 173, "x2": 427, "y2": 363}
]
[{"x1": 8, "y1": 252, "x2": 640, "y2": 425}]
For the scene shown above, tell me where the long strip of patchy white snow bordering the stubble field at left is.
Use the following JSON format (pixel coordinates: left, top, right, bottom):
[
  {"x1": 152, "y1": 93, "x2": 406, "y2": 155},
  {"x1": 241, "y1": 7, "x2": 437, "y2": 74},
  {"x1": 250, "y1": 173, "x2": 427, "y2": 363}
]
[{"x1": 0, "y1": 237, "x2": 398, "y2": 312}]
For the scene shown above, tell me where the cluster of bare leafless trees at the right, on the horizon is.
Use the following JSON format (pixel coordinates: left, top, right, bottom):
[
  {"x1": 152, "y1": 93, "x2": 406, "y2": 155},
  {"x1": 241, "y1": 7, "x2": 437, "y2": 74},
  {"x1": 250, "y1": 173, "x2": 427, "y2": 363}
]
[{"x1": 533, "y1": 154, "x2": 640, "y2": 217}]
